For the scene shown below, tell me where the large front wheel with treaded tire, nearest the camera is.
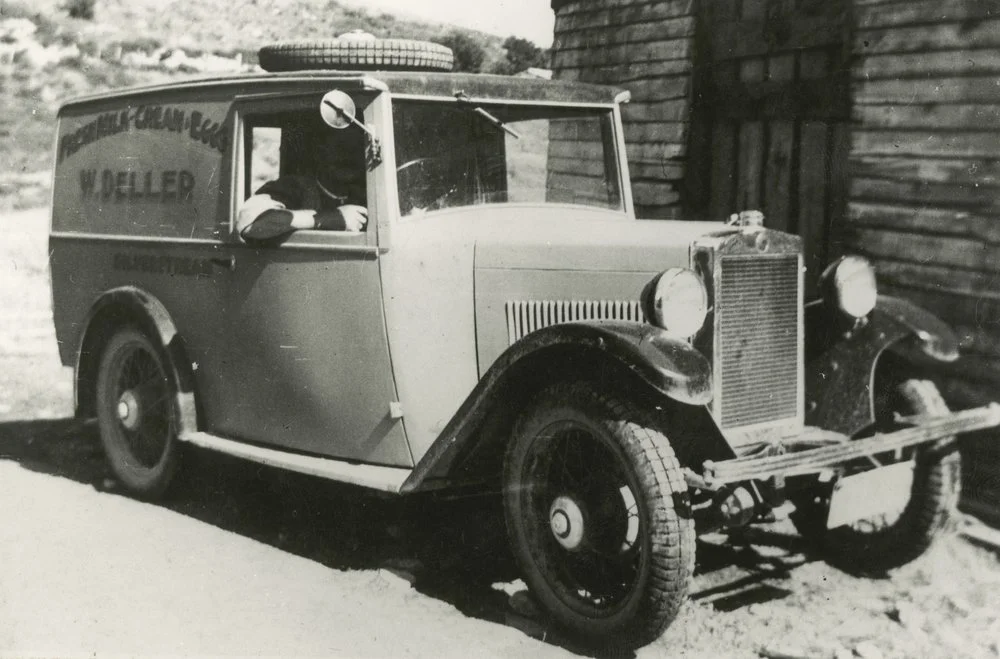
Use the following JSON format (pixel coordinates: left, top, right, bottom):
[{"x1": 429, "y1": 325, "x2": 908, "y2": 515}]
[{"x1": 504, "y1": 383, "x2": 695, "y2": 647}]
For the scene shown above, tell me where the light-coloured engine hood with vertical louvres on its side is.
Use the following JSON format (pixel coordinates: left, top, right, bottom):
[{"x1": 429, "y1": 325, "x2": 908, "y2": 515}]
[{"x1": 475, "y1": 211, "x2": 735, "y2": 376}]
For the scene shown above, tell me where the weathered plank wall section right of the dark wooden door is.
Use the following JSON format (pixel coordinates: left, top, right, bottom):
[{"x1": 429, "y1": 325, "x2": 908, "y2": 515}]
[{"x1": 845, "y1": 0, "x2": 1000, "y2": 524}]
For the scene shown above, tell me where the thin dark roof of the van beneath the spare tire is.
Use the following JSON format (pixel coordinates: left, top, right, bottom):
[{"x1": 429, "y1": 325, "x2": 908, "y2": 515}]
[{"x1": 62, "y1": 71, "x2": 626, "y2": 108}]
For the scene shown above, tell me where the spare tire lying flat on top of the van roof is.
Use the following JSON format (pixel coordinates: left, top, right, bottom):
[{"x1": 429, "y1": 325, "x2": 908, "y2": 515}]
[{"x1": 258, "y1": 31, "x2": 455, "y2": 72}]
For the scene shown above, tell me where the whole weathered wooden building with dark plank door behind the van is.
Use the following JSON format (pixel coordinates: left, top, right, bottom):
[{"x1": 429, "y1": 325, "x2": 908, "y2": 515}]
[{"x1": 551, "y1": 0, "x2": 1000, "y2": 517}]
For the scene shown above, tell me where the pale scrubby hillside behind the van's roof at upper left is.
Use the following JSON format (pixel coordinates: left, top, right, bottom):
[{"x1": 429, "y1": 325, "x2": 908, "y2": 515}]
[{"x1": 0, "y1": 0, "x2": 504, "y2": 209}]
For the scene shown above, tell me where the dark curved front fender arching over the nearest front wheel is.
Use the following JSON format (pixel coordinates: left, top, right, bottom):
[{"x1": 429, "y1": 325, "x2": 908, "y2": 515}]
[{"x1": 402, "y1": 321, "x2": 712, "y2": 492}]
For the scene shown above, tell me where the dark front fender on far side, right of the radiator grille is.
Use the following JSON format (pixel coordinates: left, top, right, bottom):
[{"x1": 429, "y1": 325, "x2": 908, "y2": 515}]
[{"x1": 805, "y1": 295, "x2": 958, "y2": 435}]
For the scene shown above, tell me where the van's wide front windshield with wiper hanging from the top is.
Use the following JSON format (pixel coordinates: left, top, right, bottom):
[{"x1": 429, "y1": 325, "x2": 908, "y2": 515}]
[{"x1": 393, "y1": 100, "x2": 622, "y2": 217}]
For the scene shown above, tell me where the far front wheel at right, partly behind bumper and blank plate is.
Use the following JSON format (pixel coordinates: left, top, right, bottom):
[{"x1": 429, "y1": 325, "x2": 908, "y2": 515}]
[{"x1": 792, "y1": 380, "x2": 961, "y2": 573}]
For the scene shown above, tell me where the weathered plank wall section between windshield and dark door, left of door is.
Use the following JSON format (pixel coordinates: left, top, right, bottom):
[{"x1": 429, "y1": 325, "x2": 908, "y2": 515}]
[{"x1": 552, "y1": 0, "x2": 695, "y2": 218}]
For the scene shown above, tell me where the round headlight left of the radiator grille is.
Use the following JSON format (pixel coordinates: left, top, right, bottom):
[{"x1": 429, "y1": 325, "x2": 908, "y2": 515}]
[{"x1": 644, "y1": 268, "x2": 708, "y2": 338}]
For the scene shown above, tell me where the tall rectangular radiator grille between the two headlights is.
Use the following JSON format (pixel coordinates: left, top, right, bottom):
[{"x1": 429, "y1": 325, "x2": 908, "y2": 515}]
[{"x1": 716, "y1": 255, "x2": 801, "y2": 428}]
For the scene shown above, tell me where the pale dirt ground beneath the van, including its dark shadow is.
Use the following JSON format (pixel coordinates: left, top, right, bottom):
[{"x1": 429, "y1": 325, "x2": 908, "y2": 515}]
[{"x1": 0, "y1": 212, "x2": 1000, "y2": 658}]
